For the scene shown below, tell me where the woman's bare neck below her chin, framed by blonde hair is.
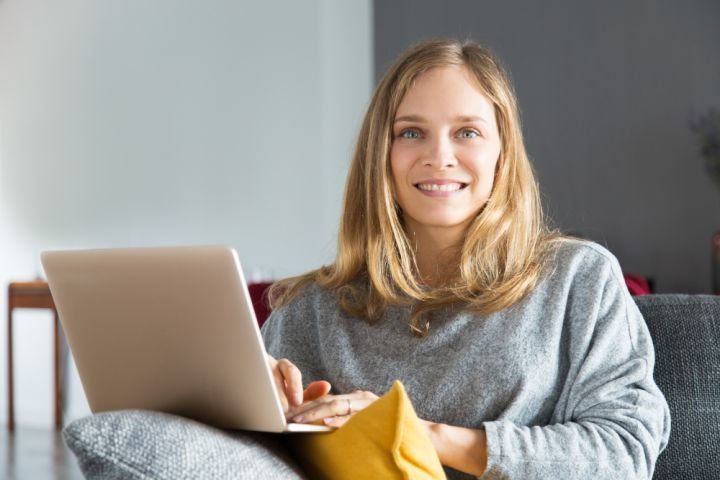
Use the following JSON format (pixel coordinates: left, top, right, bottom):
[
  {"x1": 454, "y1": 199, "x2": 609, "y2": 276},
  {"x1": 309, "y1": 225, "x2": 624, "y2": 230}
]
[{"x1": 405, "y1": 222, "x2": 467, "y2": 287}]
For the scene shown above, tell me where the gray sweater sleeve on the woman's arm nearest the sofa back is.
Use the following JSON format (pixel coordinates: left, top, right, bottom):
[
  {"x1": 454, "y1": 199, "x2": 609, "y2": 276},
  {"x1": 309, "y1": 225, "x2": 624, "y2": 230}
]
[{"x1": 481, "y1": 251, "x2": 670, "y2": 479}]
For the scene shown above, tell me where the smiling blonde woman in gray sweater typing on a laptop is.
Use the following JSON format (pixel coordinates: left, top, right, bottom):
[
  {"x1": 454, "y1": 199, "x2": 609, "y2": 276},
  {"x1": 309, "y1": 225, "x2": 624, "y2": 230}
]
[{"x1": 263, "y1": 41, "x2": 670, "y2": 479}]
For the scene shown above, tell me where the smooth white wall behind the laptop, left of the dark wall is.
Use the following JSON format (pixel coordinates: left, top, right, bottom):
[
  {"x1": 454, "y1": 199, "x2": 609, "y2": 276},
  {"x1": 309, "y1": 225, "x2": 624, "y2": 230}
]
[{"x1": 0, "y1": 0, "x2": 372, "y2": 426}]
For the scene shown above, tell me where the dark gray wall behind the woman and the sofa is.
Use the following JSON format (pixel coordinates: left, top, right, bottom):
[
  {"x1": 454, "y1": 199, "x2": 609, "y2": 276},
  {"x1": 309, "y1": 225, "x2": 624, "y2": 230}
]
[{"x1": 374, "y1": 0, "x2": 720, "y2": 292}]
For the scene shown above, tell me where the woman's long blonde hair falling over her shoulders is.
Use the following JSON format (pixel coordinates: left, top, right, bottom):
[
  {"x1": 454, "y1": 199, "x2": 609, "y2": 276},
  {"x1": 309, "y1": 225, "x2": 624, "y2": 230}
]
[{"x1": 269, "y1": 40, "x2": 556, "y2": 336}]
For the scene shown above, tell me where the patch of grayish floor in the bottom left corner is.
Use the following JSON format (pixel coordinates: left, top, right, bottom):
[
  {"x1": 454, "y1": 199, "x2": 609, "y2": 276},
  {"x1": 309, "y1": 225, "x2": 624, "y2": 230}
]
[{"x1": 0, "y1": 425, "x2": 83, "y2": 480}]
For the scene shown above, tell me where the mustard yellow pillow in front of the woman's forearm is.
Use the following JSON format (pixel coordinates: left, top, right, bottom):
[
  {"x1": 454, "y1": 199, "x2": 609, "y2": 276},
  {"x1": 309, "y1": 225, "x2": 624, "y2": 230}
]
[{"x1": 288, "y1": 381, "x2": 446, "y2": 480}]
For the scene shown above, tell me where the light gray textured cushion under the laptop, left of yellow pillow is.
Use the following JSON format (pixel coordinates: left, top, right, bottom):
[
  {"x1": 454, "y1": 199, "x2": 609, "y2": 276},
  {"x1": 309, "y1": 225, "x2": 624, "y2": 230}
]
[{"x1": 63, "y1": 410, "x2": 305, "y2": 480}]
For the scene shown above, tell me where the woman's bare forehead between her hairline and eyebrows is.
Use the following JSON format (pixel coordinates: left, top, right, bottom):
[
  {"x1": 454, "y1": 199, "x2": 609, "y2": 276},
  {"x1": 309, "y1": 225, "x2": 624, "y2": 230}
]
[{"x1": 395, "y1": 66, "x2": 495, "y2": 120}]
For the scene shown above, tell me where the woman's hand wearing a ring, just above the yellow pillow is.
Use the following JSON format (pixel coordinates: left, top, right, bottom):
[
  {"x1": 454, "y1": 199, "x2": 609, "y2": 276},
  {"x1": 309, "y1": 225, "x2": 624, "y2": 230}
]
[{"x1": 288, "y1": 390, "x2": 378, "y2": 427}]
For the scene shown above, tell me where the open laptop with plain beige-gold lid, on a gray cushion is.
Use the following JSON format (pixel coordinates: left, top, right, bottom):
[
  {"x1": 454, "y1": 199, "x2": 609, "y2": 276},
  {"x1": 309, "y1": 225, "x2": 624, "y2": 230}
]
[{"x1": 41, "y1": 246, "x2": 329, "y2": 432}]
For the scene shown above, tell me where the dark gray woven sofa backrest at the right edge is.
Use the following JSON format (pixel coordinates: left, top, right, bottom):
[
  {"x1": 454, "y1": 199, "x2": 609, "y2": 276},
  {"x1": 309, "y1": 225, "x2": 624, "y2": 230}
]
[{"x1": 635, "y1": 294, "x2": 720, "y2": 480}]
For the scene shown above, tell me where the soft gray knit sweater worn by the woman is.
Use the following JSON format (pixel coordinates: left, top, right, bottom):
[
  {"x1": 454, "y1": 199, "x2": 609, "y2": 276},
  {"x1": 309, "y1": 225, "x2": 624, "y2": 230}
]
[{"x1": 262, "y1": 240, "x2": 670, "y2": 479}]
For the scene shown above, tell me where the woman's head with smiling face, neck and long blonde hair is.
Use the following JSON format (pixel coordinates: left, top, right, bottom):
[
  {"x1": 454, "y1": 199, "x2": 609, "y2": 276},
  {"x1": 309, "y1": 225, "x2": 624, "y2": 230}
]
[{"x1": 270, "y1": 41, "x2": 558, "y2": 335}]
